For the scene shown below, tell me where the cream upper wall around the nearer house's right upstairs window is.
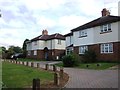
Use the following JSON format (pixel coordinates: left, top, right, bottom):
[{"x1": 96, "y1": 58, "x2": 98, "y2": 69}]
[{"x1": 94, "y1": 22, "x2": 118, "y2": 44}]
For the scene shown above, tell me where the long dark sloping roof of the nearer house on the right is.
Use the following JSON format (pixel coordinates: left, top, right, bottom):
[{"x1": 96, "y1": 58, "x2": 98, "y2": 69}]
[{"x1": 71, "y1": 15, "x2": 120, "y2": 32}]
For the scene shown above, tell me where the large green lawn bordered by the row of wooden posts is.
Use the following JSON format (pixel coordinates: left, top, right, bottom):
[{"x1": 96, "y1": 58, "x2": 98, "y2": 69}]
[{"x1": 2, "y1": 62, "x2": 53, "y2": 88}]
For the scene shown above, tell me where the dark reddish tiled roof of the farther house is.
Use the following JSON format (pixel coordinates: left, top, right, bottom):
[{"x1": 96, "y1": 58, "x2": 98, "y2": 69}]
[{"x1": 31, "y1": 33, "x2": 65, "y2": 41}]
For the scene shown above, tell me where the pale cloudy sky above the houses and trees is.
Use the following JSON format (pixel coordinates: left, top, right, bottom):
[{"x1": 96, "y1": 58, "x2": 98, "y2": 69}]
[{"x1": 0, "y1": 0, "x2": 120, "y2": 48}]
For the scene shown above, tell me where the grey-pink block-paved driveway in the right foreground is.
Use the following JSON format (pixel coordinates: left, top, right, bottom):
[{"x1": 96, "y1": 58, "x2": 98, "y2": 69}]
[{"x1": 65, "y1": 68, "x2": 118, "y2": 88}]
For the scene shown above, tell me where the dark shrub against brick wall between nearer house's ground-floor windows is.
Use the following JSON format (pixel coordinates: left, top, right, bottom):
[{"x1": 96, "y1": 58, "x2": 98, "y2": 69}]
[{"x1": 82, "y1": 50, "x2": 97, "y2": 63}]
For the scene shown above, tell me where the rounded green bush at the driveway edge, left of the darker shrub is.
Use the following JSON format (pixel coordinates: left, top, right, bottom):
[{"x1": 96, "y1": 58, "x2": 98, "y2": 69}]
[{"x1": 62, "y1": 54, "x2": 79, "y2": 67}]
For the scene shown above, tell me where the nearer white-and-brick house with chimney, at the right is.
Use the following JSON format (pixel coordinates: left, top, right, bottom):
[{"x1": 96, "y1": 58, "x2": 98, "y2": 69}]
[{"x1": 65, "y1": 8, "x2": 120, "y2": 61}]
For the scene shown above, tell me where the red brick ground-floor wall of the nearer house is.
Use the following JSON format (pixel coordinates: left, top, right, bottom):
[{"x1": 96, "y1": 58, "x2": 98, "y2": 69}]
[{"x1": 74, "y1": 42, "x2": 120, "y2": 61}]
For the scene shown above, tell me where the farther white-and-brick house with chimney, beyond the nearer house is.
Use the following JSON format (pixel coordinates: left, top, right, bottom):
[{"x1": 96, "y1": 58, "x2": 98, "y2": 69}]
[{"x1": 27, "y1": 30, "x2": 65, "y2": 60}]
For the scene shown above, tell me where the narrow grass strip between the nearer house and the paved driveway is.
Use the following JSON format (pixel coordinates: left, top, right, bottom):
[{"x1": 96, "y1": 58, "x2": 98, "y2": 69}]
[{"x1": 56, "y1": 62, "x2": 118, "y2": 70}]
